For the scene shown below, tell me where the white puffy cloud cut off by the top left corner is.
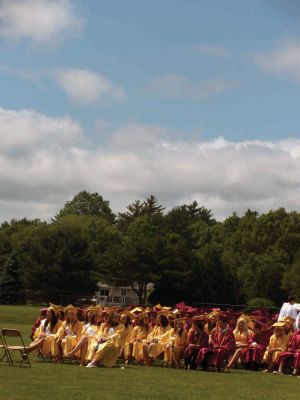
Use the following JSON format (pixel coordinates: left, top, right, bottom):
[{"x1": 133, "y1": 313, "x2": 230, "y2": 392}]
[{"x1": 0, "y1": 0, "x2": 84, "y2": 46}]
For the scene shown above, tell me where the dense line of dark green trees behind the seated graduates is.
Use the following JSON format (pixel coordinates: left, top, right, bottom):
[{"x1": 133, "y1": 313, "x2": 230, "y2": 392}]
[{"x1": 0, "y1": 191, "x2": 300, "y2": 306}]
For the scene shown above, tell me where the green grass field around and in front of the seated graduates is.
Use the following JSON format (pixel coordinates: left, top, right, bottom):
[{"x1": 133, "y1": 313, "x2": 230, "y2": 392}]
[{"x1": 0, "y1": 306, "x2": 300, "y2": 400}]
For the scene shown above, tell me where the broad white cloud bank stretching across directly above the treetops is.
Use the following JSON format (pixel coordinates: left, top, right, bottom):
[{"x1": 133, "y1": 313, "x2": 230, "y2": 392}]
[{"x1": 0, "y1": 110, "x2": 300, "y2": 221}]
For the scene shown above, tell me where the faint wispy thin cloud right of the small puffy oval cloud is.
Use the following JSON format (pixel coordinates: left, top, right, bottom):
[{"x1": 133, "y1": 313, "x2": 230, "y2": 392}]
[{"x1": 147, "y1": 74, "x2": 235, "y2": 101}]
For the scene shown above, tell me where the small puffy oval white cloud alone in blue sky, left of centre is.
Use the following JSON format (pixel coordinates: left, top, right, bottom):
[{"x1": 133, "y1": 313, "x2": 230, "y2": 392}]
[{"x1": 54, "y1": 68, "x2": 126, "y2": 104}]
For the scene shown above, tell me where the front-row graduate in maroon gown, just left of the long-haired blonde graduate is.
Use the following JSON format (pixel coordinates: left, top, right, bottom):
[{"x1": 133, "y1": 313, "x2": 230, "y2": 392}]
[{"x1": 197, "y1": 314, "x2": 235, "y2": 371}]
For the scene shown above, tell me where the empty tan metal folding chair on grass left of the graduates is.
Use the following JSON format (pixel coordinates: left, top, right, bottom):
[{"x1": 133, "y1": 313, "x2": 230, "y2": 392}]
[{"x1": 1, "y1": 328, "x2": 31, "y2": 367}]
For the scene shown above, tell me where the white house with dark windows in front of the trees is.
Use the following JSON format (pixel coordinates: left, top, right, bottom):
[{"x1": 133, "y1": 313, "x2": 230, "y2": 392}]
[{"x1": 93, "y1": 282, "x2": 153, "y2": 306}]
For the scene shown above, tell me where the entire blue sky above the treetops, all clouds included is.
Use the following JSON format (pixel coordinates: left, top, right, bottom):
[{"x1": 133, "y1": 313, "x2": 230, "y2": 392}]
[{"x1": 0, "y1": 0, "x2": 300, "y2": 219}]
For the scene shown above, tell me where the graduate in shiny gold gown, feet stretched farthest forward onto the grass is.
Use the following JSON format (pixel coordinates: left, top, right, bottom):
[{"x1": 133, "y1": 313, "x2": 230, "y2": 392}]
[{"x1": 87, "y1": 311, "x2": 126, "y2": 368}]
